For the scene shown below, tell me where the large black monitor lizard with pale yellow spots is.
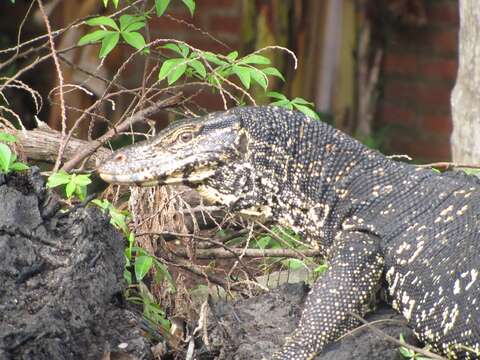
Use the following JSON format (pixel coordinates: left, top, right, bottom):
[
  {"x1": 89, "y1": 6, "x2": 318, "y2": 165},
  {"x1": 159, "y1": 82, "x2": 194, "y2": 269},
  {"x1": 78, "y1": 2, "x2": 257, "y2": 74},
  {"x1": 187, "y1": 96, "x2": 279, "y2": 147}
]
[{"x1": 98, "y1": 107, "x2": 480, "y2": 359}]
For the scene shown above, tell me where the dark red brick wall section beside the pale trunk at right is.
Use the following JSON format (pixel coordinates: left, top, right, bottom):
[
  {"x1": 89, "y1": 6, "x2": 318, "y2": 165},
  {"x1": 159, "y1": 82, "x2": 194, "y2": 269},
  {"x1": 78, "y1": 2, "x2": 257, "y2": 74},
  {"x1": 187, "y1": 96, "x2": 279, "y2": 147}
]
[{"x1": 377, "y1": 0, "x2": 459, "y2": 161}]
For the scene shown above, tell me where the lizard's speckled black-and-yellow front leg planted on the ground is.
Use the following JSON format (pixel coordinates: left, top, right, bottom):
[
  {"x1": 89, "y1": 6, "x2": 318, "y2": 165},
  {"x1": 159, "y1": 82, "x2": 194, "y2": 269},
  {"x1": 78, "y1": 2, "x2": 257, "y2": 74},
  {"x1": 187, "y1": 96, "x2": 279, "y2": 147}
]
[{"x1": 273, "y1": 231, "x2": 383, "y2": 360}]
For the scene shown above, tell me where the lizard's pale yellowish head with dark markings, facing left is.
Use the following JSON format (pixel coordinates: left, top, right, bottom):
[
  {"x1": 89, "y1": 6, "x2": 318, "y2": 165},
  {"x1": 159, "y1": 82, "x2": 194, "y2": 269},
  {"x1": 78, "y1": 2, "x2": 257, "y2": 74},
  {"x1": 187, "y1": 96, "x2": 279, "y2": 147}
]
[{"x1": 97, "y1": 111, "x2": 247, "y2": 186}]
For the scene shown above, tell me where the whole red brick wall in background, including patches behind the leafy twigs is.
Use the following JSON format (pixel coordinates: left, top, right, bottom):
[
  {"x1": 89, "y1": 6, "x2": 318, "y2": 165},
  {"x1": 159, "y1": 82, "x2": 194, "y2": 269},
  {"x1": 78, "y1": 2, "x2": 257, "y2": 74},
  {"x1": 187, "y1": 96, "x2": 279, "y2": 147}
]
[{"x1": 148, "y1": 0, "x2": 459, "y2": 161}]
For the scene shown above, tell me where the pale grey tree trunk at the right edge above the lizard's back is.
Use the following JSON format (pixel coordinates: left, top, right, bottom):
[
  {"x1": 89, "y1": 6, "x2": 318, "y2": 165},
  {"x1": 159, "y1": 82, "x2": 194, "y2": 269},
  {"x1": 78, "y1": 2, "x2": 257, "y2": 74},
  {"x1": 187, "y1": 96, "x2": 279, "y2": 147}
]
[{"x1": 451, "y1": 0, "x2": 480, "y2": 165}]
